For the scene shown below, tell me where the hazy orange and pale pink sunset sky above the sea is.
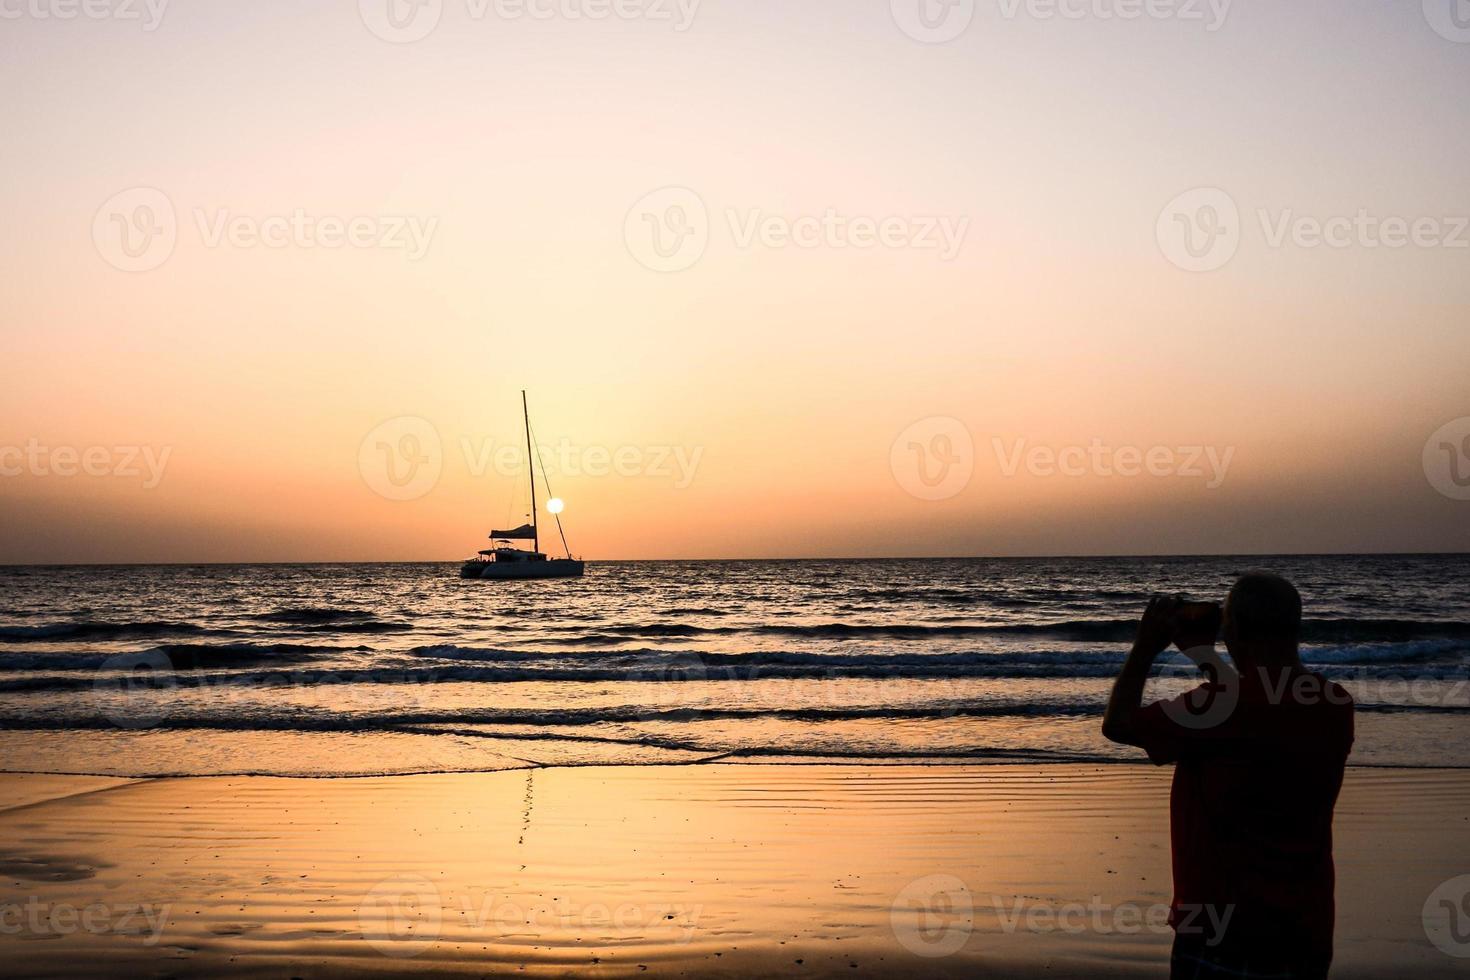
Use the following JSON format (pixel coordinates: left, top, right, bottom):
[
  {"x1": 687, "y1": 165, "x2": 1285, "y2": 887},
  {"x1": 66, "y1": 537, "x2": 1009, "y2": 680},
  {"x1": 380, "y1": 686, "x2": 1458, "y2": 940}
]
[{"x1": 0, "y1": 0, "x2": 1470, "y2": 563}]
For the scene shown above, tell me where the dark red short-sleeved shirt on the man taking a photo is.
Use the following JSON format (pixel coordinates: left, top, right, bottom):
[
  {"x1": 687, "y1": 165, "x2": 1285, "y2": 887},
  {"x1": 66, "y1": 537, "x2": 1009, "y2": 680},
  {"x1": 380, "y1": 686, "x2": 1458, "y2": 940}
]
[{"x1": 1133, "y1": 669, "x2": 1352, "y2": 955}]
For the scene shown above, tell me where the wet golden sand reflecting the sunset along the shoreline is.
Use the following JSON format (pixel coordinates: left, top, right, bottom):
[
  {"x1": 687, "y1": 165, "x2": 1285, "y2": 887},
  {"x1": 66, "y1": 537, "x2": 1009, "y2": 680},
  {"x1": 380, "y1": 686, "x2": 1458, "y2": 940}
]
[{"x1": 0, "y1": 764, "x2": 1470, "y2": 977}]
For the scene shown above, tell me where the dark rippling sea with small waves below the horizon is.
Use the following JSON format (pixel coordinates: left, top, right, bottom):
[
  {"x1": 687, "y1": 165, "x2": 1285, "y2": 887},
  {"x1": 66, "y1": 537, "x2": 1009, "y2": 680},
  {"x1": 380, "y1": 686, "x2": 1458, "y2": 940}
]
[{"x1": 0, "y1": 555, "x2": 1470, "y2": 777}]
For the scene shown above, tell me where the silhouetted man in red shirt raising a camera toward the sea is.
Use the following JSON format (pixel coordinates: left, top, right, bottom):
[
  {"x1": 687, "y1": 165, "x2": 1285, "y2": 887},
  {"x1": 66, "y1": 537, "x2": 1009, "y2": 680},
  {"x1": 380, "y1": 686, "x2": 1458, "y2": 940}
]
[{"x1": 1103, "y1": 573, "x2": 1352, "y2": 980}]
